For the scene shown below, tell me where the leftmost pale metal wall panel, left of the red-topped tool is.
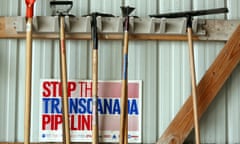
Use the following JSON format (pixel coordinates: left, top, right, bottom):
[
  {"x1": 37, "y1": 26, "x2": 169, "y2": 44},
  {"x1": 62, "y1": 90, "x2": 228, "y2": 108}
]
[{"x1": 0, "y1": 1, "x2": 19, "y2": 141}]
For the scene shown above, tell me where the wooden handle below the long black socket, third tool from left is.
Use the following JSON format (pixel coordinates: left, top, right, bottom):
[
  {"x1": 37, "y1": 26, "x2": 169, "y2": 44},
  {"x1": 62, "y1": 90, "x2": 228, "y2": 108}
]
[{"x1": 92, "y1": 48, "x2": 99, "y2": 144}]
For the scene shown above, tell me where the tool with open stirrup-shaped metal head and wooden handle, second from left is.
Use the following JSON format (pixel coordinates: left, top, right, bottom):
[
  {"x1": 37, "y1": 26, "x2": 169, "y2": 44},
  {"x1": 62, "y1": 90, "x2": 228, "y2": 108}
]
[{"x1": 50, "y1": 1, "x2": 73, "y2": 144}]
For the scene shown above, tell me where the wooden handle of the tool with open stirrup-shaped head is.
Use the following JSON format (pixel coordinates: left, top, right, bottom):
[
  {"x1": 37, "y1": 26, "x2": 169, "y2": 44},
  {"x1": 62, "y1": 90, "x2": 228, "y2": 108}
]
[{"x1": 60, "y1": 16, "x2": 70, "y2": 144}]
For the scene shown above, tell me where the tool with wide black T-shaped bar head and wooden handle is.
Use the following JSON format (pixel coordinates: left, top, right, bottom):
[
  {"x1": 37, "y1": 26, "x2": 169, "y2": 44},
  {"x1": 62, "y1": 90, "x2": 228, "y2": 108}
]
[{"x1": 150, "y1": 8, "x2": 228, "y2": 144}]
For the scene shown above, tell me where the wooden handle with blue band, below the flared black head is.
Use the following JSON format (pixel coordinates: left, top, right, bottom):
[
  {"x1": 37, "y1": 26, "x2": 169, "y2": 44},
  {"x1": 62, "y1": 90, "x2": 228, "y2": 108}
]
[{"x1": 119, "y1": 31, "x2": 128, "y2": 144}]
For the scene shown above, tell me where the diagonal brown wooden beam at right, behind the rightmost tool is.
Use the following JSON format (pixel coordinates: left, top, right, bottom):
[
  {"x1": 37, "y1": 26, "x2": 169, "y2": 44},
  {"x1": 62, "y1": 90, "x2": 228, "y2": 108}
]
[{"x1": 157, "y1": 25, "x2": 240, "y2": 144}]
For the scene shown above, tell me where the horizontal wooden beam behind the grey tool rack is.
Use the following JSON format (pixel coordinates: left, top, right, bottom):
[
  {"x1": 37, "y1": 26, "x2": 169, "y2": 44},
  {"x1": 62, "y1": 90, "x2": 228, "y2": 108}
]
[{"x1": 0, "y1": 17, "x2": 240, "y2": 41}]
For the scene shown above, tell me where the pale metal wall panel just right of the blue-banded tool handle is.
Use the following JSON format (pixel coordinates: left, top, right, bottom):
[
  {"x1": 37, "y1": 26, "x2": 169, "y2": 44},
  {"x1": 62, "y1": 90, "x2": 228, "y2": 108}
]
[{"x1": 125, "y1": 0, "x2": 158, "y2": 143}]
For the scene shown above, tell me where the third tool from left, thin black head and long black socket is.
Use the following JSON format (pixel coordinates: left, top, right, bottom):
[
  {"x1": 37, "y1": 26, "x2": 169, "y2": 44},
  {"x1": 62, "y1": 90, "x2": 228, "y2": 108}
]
[{"x1": 84, "y1": 12, "x2": 113, "y2": 144}]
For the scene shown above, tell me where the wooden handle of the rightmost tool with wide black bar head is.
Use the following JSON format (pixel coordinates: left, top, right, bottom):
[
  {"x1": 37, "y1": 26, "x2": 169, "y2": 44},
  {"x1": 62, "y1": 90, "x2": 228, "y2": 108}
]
[{"x1": 187, "y1": 28, "x2": 200, "y2": 144}]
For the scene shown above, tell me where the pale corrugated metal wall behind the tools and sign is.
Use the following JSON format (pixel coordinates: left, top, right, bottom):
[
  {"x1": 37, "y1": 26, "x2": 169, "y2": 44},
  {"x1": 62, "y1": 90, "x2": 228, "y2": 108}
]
[{"x1": 0, "y1": 0, "x2": 240, "y2": 143}]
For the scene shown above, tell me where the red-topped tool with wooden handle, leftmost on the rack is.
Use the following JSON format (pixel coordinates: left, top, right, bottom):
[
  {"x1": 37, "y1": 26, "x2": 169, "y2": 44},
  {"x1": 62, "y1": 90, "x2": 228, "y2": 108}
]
[{"x1": 24, "y1": 0, "x2": 35, "y2": 144}]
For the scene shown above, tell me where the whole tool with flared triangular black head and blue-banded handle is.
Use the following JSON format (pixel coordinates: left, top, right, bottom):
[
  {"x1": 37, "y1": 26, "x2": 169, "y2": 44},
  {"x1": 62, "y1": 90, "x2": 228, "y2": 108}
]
[{"x1": 119, "y1": 6, "x2": 135, "y2": 144}]
